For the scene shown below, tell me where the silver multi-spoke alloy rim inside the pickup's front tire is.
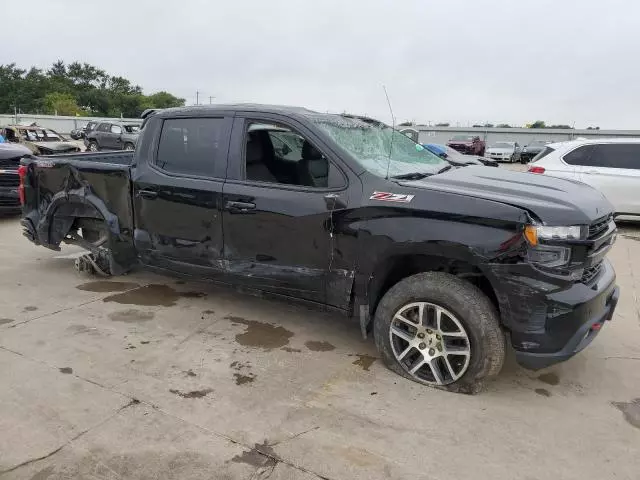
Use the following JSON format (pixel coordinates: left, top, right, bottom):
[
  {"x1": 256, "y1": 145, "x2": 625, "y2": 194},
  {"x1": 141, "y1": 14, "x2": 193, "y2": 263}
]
[{"x1": 389, "y1": 302, "x2": 471, "y2": 385}]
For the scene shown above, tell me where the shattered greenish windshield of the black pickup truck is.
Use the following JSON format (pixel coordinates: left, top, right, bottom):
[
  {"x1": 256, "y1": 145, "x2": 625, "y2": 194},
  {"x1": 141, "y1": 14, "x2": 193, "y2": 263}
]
[{"x1": 311, "y1": 115, "x2": 449, "y2": 178}]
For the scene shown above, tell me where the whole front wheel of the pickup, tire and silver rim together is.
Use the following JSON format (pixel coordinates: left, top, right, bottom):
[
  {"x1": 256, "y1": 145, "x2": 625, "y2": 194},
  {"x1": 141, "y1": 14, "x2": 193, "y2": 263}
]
[{"x1": 374, "y1": 272, "x2": 506, "y2": 393}]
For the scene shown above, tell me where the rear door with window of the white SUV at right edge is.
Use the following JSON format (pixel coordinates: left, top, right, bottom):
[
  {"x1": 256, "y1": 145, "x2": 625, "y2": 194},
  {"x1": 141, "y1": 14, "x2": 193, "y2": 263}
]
[{"x1": 582, "y1": 143, "x2": 640, "y2": 215}]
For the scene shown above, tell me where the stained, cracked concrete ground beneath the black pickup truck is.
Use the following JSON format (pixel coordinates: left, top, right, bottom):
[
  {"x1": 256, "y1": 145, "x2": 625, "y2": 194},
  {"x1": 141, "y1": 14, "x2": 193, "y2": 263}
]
[{"x1": 0, "y1": 203, "x2": 640, "y2": 480}]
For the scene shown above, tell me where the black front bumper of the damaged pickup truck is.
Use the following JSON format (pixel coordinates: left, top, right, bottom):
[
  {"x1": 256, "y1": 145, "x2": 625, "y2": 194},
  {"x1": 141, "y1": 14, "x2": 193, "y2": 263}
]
[{"x1": 492, "y1": 259, "x2": 620, "y2": 370}]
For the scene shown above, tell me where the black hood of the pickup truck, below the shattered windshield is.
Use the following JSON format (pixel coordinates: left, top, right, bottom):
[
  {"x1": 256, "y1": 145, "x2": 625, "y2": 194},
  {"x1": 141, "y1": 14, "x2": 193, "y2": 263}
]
[{"x1": 401, "y1": 166, "x2": 614, "y2": 226}]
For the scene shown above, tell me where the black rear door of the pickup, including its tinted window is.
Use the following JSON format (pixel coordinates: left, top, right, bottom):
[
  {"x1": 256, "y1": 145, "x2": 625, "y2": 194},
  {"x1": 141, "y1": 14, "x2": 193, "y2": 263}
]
[{"x1": 133, "y1": 112, "x2": 232, "y2": 278}]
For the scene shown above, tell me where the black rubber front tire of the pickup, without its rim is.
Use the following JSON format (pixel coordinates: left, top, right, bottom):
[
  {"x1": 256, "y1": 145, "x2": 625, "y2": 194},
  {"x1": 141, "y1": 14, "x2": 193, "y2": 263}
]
[{"x1": 373, "y1": 272, "x2": 506, "y2": 394}]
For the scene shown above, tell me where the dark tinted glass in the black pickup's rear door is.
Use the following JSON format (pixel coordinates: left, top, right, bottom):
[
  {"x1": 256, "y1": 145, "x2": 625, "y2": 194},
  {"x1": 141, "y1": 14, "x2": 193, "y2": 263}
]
[{"x1": 156, "y1": 118, "x2": 228, "y2": 177}]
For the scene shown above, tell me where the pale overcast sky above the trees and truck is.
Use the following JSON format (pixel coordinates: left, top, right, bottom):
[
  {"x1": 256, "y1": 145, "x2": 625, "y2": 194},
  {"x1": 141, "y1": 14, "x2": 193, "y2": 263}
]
[{"x1": 5, "y1": 0, "x2": 640, "y2": 128}]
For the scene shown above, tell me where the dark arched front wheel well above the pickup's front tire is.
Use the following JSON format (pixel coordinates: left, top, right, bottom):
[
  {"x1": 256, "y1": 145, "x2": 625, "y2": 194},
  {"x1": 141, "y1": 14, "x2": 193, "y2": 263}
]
[{"x1": 368, "y1": 255, "x2": 500, "y2": 324}]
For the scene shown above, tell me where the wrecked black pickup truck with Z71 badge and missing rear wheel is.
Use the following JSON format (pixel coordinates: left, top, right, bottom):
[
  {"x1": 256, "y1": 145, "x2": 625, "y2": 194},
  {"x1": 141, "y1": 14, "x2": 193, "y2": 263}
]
[{"x1": 20, "y1": 105, "x2": 619, "y2": 393}]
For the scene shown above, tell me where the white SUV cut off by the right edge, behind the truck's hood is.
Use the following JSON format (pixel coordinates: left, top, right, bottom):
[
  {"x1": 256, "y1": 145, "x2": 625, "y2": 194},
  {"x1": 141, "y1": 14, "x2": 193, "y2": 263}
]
[{"x1": 529, "y1": 138, "x2": 640, "y2": 220}]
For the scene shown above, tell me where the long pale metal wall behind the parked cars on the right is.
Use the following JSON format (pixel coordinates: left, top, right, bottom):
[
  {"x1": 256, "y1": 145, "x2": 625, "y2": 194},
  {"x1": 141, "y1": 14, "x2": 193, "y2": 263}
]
[{"x1": 412, "y1": 125, "x2": 640, "y2": 145}]
